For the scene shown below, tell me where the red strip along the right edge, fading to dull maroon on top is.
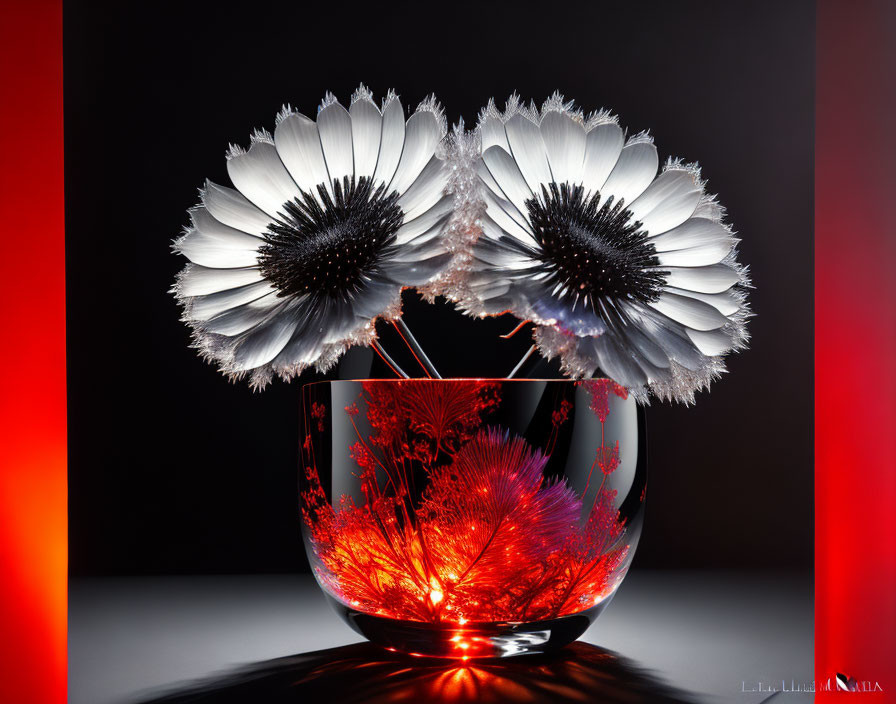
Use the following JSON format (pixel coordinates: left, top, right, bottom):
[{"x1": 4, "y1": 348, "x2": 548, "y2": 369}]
[{"x1": 815, "y1": 0, "x2": 896, "y2": 701}]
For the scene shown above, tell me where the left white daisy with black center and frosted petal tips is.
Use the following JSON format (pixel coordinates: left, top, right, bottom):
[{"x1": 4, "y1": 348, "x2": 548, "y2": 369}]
[{"x1": 173, "y1": 86, "x2": 454, "y2": 387}]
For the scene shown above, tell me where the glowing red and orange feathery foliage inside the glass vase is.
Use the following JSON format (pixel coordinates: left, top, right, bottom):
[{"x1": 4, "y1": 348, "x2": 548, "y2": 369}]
[{"x1": 302, "y1": 381, "x2": 628, "y2": 624}]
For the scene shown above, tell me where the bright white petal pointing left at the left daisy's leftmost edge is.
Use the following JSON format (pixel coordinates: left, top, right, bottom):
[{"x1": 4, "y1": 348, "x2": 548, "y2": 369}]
[{"x1": 176, "y1": 208, "x2": 263, "y2": 269}]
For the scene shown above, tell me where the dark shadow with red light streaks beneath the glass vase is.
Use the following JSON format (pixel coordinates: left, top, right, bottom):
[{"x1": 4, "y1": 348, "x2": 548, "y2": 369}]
[{"x1": 141, "y1": 642, "x2": 698, "y2": 704}]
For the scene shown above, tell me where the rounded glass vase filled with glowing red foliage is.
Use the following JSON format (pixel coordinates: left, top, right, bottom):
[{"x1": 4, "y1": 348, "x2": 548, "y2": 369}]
[{"x1": 300, "y1": 379, "x2": 647, "y2": 659}]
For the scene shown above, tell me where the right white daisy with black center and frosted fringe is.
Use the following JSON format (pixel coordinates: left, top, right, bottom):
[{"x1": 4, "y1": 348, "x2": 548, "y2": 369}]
[{"x1": 446, "y1": 94, "x2": 749, "y2": 402}]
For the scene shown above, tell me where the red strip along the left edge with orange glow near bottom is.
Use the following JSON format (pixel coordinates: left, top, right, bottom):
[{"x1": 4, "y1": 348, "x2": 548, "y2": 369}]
[{"x1": 0, "y1": 0, "x2": 68, "y2": 704}]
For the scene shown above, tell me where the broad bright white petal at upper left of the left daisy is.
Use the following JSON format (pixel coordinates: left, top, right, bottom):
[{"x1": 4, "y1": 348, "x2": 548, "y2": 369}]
[{"x1": 227, "y1": 142, "x2": 299, "y2": 217}]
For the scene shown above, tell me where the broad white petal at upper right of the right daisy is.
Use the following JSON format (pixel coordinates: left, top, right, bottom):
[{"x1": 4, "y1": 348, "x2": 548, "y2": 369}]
[{"x1": 628, "y1": 169, "x2": 703, "y2": 235}]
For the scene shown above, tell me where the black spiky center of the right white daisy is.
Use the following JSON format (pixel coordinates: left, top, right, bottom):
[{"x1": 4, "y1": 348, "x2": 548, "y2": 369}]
[{"x1": 526, "y1": 183, "x2": 665, "y2": 306}]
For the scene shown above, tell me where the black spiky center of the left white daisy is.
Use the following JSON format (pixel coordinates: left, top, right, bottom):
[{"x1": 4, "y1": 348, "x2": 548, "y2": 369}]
[{"x1": 259, "y1": 176, "x2": 404, "y2": 298}]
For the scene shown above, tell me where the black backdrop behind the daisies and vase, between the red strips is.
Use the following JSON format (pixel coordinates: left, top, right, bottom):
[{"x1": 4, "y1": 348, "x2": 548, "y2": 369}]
[{"x1": 66, "y1": 0, "x2": 814, "y2": 575}]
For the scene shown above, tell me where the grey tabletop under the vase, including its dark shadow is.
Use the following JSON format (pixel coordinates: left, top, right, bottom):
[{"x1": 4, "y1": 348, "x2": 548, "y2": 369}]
[{"x1": 69, "y1": 566, "x2": 813, "y2": 704}]
